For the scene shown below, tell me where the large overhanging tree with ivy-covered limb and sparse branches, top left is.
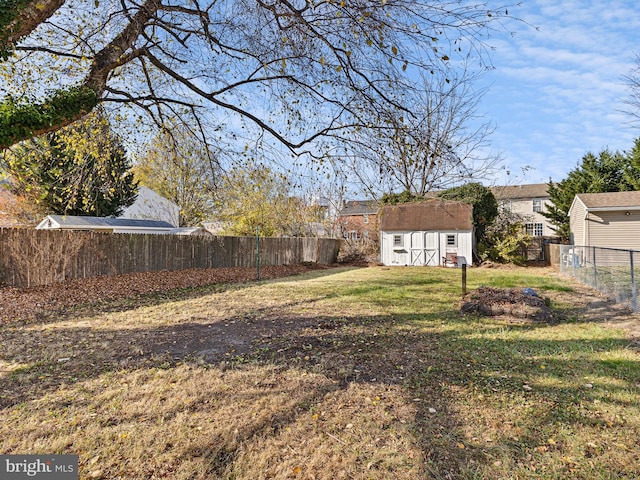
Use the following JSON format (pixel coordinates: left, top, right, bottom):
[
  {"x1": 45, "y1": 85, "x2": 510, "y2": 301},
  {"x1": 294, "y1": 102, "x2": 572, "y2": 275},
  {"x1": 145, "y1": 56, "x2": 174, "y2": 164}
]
[{"x1": 0, "y1": 0, "x2": 509, "y2": 159}]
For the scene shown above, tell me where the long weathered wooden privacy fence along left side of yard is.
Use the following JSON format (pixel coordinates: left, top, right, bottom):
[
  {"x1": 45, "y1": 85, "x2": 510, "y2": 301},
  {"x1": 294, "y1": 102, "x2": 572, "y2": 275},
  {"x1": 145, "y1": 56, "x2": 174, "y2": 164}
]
[{"x1": 0, "y1": 228, "x2": 340, "y2": 287}]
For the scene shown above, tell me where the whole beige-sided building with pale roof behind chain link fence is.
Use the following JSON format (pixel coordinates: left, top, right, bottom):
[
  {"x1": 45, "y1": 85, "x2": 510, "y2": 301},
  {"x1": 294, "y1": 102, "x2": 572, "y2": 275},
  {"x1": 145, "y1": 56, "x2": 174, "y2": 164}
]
[{"x1": 569, "y1": 192, "x2": 640, "y2": 250}]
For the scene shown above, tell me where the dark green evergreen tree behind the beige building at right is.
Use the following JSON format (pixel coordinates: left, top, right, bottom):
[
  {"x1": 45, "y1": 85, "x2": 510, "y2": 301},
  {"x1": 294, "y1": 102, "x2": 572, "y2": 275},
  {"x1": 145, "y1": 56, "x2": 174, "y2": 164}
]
[{"x1": 541, "y1": 144, "x2": 640, "y2": 240}]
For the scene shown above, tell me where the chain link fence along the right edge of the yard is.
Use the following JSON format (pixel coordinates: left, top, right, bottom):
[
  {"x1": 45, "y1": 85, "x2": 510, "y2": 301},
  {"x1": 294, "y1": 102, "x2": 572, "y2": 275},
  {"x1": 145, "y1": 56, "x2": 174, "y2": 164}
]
[{"x1": 560, "y1": 245, "x2": 640, "y2": 312}]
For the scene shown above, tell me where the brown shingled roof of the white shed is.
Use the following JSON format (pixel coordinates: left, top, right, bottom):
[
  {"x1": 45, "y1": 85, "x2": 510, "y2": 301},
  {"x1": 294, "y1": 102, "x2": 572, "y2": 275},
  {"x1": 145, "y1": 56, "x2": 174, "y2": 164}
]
[{"x1": 380, "y1": 200, "x2": 473, "y2": 232}]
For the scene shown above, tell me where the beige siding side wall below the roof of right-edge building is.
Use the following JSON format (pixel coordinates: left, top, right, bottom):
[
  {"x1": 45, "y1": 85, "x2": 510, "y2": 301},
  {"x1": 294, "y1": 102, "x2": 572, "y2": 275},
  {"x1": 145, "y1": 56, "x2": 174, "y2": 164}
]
[{"x1": 586, "y1": 210, "x2": 640, "y2": 250}]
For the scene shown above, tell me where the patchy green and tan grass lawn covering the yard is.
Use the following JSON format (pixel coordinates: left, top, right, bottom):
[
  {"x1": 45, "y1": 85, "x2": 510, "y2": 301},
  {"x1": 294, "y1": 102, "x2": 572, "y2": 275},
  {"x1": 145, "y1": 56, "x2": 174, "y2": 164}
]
[{"x1": 0, "y1": 267, "x2": 640, "y2": 480}]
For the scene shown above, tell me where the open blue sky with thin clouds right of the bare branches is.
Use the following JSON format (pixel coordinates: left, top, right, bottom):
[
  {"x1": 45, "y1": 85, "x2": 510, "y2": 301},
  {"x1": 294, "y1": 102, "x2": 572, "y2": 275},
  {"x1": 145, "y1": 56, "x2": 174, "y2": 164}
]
[{"x1": 480, "y1": 0, "x2": 640, "y2": 184}]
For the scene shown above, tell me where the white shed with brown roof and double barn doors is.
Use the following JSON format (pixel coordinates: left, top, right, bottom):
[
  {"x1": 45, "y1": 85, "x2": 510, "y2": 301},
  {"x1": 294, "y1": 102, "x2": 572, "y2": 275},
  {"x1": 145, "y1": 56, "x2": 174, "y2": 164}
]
[{"x1": 380, "y1": 199, "x2": 474, "y2": 266}]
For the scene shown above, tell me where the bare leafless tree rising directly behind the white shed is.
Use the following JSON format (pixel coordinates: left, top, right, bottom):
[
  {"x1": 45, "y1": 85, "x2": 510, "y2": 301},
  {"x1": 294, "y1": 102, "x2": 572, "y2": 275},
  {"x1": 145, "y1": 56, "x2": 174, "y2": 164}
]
[{"x1": 340, "y1": 65, "x2": 500, "y2": 196}]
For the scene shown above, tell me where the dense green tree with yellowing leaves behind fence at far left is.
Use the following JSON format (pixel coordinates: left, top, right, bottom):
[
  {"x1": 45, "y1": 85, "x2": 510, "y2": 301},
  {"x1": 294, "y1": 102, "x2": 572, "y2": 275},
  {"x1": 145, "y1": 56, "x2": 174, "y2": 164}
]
[{"x1": 0, "y1": 112, "x2": 138, "y2": 217}]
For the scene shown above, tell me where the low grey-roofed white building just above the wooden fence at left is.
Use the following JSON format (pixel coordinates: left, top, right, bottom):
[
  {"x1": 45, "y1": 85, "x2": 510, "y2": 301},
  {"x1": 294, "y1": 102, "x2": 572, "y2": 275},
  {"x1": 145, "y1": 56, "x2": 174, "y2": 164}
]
[{"x1": 36, "y1": 215, "x2": 176, "y2": 234}]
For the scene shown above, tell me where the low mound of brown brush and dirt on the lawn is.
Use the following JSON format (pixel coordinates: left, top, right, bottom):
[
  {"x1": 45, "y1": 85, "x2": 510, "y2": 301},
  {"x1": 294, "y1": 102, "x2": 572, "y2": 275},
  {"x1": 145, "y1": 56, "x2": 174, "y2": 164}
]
[{"x1": 460, "y1": 287, "x2": 555, "y2": 322}]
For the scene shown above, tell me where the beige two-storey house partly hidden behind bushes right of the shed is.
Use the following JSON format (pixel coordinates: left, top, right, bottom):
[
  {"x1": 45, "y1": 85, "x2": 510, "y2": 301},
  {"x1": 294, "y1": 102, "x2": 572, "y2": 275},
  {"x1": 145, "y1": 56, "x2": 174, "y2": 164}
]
[{"x1": 491, "y1": 183, "x2": 555, "y2": 237}]
